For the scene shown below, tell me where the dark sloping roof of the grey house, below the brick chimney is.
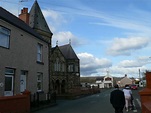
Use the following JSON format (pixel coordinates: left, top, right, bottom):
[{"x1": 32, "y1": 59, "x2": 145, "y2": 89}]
[{"x1": 0, "y1": 7, "x2": 44, "y2": 41}]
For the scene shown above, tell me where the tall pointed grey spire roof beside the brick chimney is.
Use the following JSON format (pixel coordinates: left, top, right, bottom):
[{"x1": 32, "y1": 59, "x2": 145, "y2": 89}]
[{"x1": 29, "y1": 0, "x2": 52, "y2": 34}]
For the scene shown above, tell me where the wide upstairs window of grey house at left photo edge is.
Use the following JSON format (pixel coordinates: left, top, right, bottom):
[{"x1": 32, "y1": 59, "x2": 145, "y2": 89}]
[{"x1": 0, "y1": 26, "x2": 10, "y2": 48}]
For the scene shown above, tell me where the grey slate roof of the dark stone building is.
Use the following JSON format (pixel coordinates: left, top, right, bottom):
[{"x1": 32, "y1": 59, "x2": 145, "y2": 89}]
[{"x1": 52, "y1": 44, "x2": 79, "y2": 60}]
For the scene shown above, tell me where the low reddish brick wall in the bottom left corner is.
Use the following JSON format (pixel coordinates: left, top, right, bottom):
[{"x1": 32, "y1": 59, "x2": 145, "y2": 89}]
[{"x1": 0, "y1": 92, "x2": 30, "y2": 113}]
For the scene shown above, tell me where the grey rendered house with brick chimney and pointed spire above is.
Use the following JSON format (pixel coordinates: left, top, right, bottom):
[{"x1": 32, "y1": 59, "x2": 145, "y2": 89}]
[{"x1": 0, "y1": 1, "x2": 52, "y2": 96}]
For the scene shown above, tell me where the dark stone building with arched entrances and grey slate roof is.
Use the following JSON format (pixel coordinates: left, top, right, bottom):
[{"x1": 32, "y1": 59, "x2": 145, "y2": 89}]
[{"x1": 51, "y1": 44, "x2": 80, "y2": 94}]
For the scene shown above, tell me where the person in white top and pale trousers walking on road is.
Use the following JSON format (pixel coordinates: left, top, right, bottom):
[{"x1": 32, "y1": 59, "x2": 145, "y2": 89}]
[{"x1": 123, "y1": 85, "x2": 132, "y2": 112}]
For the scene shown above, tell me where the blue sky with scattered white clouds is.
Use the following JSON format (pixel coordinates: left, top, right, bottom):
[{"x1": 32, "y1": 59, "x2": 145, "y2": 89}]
[{"x1": 0, "y1": 0, "x2": 151, "y2": 78}]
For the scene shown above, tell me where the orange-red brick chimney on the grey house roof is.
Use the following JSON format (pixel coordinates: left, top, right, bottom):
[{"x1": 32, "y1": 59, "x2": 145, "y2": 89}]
[{"x1": 19, "y1": 8, "x2": 29, "y2": 25}]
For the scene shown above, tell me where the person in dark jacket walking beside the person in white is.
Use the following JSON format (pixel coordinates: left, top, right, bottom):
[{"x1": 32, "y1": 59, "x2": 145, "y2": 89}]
[{"x1": 110, "y1": 84, "x2": 125, "y2": 113}]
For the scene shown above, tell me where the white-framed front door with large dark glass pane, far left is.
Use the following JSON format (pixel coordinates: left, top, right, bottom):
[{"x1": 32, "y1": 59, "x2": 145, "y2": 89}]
[{"x1": 4, "y1": 75, "x2": 14, "y2": 96}]
